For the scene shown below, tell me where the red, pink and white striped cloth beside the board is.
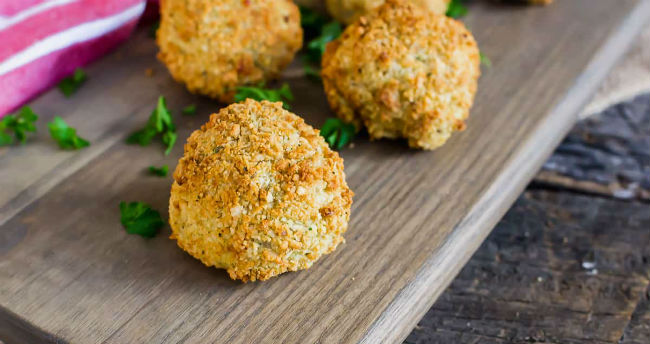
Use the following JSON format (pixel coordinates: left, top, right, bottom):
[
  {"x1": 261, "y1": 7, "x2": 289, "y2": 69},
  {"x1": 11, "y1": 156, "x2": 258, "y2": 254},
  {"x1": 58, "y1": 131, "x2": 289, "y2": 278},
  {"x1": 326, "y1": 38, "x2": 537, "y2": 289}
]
[{"x1": 0, "y1": 0, "x2": 146, "y2": 117}]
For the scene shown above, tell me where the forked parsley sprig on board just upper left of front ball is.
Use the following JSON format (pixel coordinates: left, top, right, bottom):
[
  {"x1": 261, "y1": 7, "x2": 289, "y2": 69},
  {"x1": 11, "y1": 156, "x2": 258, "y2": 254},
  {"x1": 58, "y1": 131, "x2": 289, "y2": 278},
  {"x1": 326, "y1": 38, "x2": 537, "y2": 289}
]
[{"x1": 126, "y1": 96, "x2": 177, "y2": 155}]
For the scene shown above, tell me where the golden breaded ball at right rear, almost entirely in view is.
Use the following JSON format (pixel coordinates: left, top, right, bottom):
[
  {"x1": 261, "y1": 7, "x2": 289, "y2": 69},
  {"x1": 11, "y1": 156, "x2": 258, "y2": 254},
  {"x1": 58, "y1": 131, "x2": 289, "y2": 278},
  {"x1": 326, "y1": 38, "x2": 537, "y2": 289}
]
[{"x1": 322, "y1": 0, "x2": 480, "y2": 149}]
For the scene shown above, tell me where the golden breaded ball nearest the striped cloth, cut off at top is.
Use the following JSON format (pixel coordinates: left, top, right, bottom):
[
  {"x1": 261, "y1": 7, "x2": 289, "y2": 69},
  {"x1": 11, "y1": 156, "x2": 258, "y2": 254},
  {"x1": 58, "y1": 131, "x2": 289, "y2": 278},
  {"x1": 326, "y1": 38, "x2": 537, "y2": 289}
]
[{"x1": 156, "y1": 0, "x2": 302, "y2": 103}]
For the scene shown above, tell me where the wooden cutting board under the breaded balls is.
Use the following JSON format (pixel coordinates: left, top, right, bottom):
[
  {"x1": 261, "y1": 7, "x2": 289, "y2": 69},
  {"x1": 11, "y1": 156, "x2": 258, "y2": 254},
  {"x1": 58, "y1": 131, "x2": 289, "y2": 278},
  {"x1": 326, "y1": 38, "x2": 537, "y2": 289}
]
[{"x1": 0, "y1": 0, "x2": 650, "y2": 344}]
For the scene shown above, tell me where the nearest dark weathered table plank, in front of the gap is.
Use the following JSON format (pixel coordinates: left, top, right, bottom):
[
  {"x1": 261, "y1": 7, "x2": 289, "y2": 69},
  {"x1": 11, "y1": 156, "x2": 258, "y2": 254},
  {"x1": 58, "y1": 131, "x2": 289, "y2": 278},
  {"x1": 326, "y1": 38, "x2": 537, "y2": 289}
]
[{"x1": 407, "y1": 190, "x2": 650, "y2": 344}]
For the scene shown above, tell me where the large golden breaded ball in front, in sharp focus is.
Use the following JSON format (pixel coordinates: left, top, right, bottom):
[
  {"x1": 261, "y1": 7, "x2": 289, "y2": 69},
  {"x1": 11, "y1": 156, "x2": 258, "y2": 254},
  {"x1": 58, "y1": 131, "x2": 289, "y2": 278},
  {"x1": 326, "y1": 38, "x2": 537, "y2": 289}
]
[{"x1": 169, "y1": 99, "x2": 353, "y2": 282}]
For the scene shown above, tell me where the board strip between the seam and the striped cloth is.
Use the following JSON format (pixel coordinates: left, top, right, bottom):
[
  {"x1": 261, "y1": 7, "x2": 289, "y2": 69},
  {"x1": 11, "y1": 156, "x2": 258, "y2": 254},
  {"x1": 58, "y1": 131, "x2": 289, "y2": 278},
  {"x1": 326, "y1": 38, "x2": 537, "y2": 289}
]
[{"x1": 0, "y1": 30, "x2": 201, "y2": 224}]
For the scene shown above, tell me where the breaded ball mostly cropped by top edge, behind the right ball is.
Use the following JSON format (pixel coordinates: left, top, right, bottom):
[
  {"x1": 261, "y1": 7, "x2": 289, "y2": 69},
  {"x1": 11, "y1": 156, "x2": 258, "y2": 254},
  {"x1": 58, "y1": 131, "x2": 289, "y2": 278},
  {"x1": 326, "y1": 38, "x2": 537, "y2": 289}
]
[{"x1": 325, "y1": 0, "x2": 451, "y2": 24}]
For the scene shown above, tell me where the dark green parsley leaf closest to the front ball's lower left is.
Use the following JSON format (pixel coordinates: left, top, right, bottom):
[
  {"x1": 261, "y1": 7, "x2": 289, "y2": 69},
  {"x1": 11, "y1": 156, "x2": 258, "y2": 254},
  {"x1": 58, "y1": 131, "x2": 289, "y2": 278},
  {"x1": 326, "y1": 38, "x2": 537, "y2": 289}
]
[{"x1": 120, "y1": 202, "x2": 165, "y2": 238}]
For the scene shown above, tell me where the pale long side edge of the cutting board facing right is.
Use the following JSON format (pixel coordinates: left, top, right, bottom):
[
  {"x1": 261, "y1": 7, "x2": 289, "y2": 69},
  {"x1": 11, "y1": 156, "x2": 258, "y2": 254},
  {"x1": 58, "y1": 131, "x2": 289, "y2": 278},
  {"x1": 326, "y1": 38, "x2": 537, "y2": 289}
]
[{"x1": 359, "y1": 0, "x2": 650, "y2": 344}]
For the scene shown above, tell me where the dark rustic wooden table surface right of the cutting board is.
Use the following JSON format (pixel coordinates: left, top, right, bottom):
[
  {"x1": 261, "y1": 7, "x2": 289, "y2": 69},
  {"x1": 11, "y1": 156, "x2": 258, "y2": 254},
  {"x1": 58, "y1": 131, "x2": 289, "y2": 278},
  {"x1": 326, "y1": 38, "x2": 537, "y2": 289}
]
[{"x1": 406, "y1": 95, "x2": 650, "y2": 344}]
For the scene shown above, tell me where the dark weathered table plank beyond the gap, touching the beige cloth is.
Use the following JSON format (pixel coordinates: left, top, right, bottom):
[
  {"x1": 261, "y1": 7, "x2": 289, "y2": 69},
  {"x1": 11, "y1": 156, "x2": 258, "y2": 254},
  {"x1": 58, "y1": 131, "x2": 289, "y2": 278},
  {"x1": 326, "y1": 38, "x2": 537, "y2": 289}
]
[{"x1": 535, "y1": 94, "x2": 650, "y2": 200}]
